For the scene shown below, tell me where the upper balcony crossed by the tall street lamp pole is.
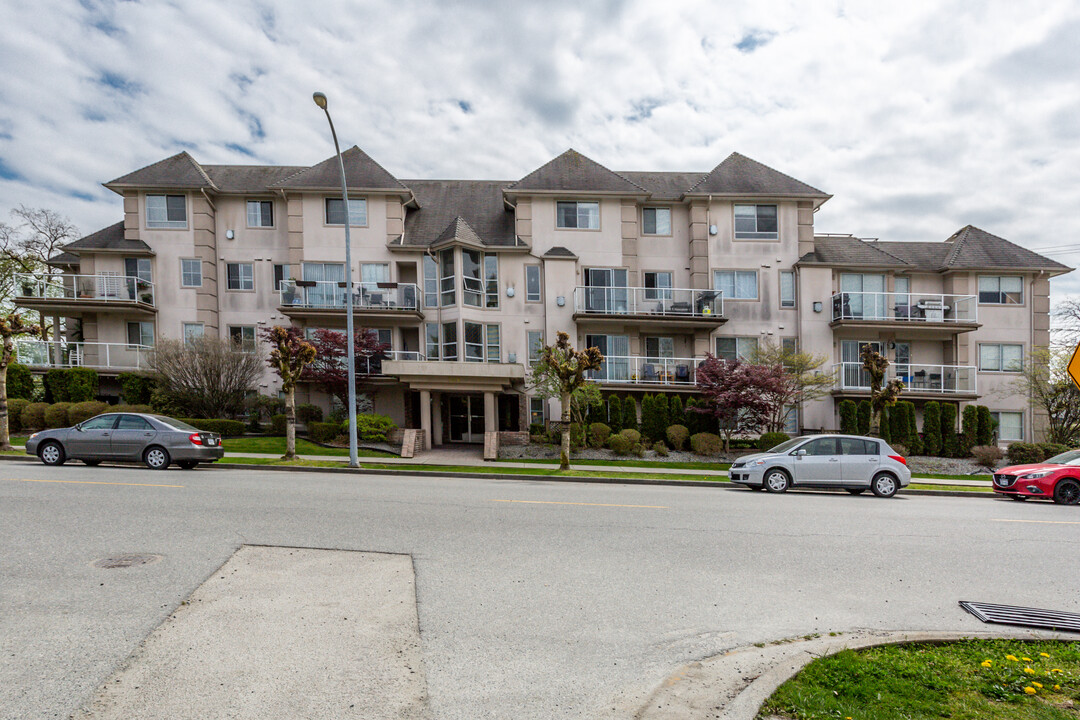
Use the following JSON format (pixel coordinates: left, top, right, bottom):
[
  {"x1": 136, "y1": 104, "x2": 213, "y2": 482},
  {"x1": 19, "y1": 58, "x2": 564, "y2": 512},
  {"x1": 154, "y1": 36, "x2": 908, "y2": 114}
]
[{"x1": 280, "y1": 280, "x2": 423, "y2": 320}]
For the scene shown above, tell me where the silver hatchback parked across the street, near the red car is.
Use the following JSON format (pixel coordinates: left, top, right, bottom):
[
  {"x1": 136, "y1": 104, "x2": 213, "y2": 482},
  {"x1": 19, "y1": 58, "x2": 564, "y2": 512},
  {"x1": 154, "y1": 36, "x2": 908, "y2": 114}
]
[{"x1": 728, "y1": 435, "x2": 912, "y2": 498}]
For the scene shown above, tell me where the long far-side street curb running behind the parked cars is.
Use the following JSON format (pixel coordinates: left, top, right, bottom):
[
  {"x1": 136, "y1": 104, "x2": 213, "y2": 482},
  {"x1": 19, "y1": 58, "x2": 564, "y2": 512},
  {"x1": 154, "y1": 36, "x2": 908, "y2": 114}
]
[{"x1": 0, "y1": 456, "x2": 997, "y2": 500}]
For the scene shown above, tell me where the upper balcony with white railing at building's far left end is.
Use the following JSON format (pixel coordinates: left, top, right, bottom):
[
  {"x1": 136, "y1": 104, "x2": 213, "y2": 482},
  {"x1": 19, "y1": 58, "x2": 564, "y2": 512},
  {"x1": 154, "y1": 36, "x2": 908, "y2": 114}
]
[{"x1": 15, "y1": 273, "x2": 157, "y2": 314}]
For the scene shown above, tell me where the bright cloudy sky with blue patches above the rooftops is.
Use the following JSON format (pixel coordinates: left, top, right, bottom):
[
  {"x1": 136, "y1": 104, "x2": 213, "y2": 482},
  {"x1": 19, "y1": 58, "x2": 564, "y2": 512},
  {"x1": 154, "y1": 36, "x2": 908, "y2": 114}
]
[{"x1": 0, "y1": 0, "x2": 1080, "y2": 295}]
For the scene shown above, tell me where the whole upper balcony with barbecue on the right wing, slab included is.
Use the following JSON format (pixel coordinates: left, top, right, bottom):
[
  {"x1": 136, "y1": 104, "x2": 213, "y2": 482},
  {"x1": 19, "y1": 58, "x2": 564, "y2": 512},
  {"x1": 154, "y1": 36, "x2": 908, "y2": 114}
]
[{"x1": 832, "y1": 293, "x2": 978, "y2": 332}]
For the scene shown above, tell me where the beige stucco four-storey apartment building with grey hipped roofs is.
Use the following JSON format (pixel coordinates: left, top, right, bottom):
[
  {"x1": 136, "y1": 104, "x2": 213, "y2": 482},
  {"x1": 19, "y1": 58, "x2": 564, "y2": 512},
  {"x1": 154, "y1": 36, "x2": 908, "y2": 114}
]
[{"x1": 16, "y1": 147, "x2": 1070, "y2": 447}]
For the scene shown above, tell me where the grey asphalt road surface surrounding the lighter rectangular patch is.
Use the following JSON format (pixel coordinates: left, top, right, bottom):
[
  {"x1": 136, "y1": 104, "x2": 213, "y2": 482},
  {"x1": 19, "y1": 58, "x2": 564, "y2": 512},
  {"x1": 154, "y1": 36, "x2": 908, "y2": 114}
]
[{"x1": 0, "y1": 462, "x2": 1080, "y2": 720}]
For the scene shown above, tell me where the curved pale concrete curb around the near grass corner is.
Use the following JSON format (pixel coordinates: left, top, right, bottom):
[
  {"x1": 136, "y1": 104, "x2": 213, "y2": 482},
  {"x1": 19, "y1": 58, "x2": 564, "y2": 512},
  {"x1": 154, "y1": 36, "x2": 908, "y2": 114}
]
[{"x1": 634, "y1": 630, "x2": 1077, "y2": 720}]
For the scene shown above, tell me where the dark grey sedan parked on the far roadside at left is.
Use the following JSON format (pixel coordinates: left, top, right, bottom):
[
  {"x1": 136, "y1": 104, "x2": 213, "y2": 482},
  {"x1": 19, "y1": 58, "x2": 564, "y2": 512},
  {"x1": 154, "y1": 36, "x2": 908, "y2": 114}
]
[{"x1": 26, "y1": 412, "x2": 225, "y2": 470}]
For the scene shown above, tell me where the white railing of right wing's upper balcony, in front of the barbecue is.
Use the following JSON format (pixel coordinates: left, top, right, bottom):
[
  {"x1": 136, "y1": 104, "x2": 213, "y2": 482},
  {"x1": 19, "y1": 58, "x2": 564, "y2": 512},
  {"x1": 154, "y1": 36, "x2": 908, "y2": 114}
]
[{"x1": 833, "y1": 293, "x2": 978, "y2": 323}]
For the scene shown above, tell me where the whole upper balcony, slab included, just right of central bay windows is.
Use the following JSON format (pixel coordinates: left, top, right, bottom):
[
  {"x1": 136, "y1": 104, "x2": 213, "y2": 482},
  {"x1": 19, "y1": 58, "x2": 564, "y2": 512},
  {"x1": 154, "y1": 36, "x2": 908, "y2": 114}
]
[{"x1": 573, "y1": 287, "x2": 727, "y2": 328}]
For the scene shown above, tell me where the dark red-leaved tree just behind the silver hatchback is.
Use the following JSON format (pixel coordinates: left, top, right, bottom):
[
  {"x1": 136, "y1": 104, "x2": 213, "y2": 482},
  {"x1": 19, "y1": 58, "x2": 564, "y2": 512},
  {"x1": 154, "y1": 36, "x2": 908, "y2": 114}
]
[{"x1": 691, "y1": 353, "x2": 784, "y2": 452}]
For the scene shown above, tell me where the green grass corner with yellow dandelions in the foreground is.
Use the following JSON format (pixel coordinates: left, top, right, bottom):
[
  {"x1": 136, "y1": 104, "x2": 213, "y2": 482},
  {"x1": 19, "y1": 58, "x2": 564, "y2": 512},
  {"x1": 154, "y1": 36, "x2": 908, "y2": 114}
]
[{"x1": 759, "y1": 640, "x2": 1080, "y2": 720}]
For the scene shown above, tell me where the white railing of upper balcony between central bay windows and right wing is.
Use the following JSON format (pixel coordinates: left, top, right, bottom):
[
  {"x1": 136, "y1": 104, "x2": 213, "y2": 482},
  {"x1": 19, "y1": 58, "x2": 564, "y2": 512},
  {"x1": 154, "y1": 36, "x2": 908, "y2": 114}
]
[{"x1": 573, "y1": 287, "x2": 724, "y2": 320}]
